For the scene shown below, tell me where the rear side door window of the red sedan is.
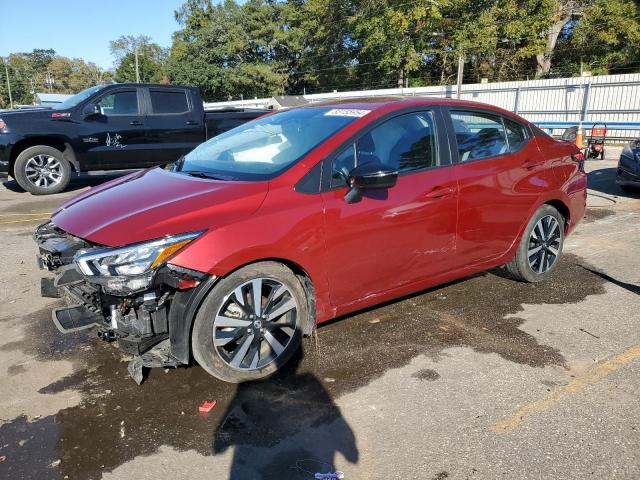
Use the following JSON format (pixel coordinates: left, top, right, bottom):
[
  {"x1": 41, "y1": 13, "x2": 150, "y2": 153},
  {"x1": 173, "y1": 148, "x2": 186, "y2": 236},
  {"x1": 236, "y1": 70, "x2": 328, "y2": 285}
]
[{"x1": 451, "y1": 111, "x2": 509, "y2": 162}]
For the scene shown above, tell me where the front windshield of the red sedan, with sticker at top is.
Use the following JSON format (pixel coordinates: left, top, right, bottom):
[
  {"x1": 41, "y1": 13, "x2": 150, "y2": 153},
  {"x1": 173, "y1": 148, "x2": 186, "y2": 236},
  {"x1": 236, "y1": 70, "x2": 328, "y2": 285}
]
[{"x1": 177, "y1": 107, "x2": 369, "y2": 180}]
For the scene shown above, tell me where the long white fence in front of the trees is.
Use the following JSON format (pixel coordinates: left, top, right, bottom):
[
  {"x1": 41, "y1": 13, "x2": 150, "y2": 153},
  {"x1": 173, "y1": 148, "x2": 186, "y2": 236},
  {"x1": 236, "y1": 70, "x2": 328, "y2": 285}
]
[{"x1": 205, "y1": 73, "x2": 640, "y2": 138}]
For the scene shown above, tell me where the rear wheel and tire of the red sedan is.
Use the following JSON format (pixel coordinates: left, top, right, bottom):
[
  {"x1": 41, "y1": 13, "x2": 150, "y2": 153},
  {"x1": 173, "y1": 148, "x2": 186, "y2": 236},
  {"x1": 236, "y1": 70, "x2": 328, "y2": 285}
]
[{"x1": 505, "y1": 205, "x2": 565, "y2": 283}]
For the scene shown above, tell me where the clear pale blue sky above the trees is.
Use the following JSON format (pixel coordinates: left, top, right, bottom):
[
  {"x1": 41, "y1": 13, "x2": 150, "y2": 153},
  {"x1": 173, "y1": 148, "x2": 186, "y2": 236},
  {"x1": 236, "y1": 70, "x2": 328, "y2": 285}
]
[{"x1": 0, "y1": 0, "x2": 184, "y2": 68}]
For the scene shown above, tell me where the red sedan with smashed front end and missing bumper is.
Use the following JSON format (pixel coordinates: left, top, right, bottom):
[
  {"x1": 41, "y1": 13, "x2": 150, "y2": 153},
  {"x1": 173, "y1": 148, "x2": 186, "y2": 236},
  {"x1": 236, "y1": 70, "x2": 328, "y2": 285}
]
[{"x1": 35, "y1": 98, "x2": 586, "y2": 382}]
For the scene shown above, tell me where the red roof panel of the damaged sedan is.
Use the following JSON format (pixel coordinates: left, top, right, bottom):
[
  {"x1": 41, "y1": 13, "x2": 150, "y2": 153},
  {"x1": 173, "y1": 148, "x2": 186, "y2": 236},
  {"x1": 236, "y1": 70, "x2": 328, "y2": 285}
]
[{"x1": 301, "y1": 95, "x2": 526, "y2": 121}]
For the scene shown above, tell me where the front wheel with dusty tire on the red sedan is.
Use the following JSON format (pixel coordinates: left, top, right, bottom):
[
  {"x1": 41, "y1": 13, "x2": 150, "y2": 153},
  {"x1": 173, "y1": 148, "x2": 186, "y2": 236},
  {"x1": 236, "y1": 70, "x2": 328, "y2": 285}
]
[{"x1": 192, "y1": 262, "x2": 308, "y2": 383}]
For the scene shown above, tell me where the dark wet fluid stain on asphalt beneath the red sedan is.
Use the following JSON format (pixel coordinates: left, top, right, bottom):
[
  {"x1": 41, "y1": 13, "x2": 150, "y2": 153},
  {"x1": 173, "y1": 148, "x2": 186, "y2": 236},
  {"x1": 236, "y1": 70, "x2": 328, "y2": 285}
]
[{"x1": 0, "y1": 255, "x2": 605, "y2": 478}]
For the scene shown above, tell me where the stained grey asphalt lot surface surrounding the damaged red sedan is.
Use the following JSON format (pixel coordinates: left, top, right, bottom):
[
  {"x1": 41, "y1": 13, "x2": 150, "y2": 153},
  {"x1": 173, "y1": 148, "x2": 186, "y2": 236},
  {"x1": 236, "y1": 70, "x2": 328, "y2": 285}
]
[{"x1": 0, "y1": 155, "x2": 640, "y2": 480}]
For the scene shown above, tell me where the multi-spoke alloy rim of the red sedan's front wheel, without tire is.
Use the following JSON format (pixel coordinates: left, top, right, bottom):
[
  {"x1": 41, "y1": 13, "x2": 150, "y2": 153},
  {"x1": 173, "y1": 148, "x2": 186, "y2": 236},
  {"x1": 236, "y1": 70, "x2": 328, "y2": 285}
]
[{"x1": 213, "y1": 278, "x2": 298, "y2": 371}]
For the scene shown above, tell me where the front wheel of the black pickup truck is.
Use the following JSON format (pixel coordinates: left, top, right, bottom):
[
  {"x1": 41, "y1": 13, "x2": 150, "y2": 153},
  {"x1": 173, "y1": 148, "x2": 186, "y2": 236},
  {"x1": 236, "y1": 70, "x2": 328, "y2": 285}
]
[{"x1": 13, "y1": 145, "x2": 71, "y2": 195}]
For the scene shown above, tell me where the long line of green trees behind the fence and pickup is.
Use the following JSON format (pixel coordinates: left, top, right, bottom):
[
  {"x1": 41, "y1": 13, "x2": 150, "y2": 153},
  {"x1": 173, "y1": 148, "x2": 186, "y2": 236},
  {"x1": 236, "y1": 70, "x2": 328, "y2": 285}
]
[{"x1": 0, "y1": 0, "x2": 640, "y2": 108}]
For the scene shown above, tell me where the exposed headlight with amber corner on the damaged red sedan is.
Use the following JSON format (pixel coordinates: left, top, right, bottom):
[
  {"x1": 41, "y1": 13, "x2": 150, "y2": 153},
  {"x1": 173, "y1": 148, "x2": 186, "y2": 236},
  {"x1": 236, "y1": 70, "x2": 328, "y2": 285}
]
[{"x1": 74, "y1": 232, "x2": 202, "y2": 295}]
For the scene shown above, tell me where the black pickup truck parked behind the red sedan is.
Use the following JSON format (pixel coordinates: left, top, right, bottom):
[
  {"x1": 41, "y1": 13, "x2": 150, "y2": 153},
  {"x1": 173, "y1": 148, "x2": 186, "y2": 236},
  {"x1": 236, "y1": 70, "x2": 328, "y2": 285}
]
[{"x1": 0, "y1": 84, "x2": 267, "y2": 195}]
